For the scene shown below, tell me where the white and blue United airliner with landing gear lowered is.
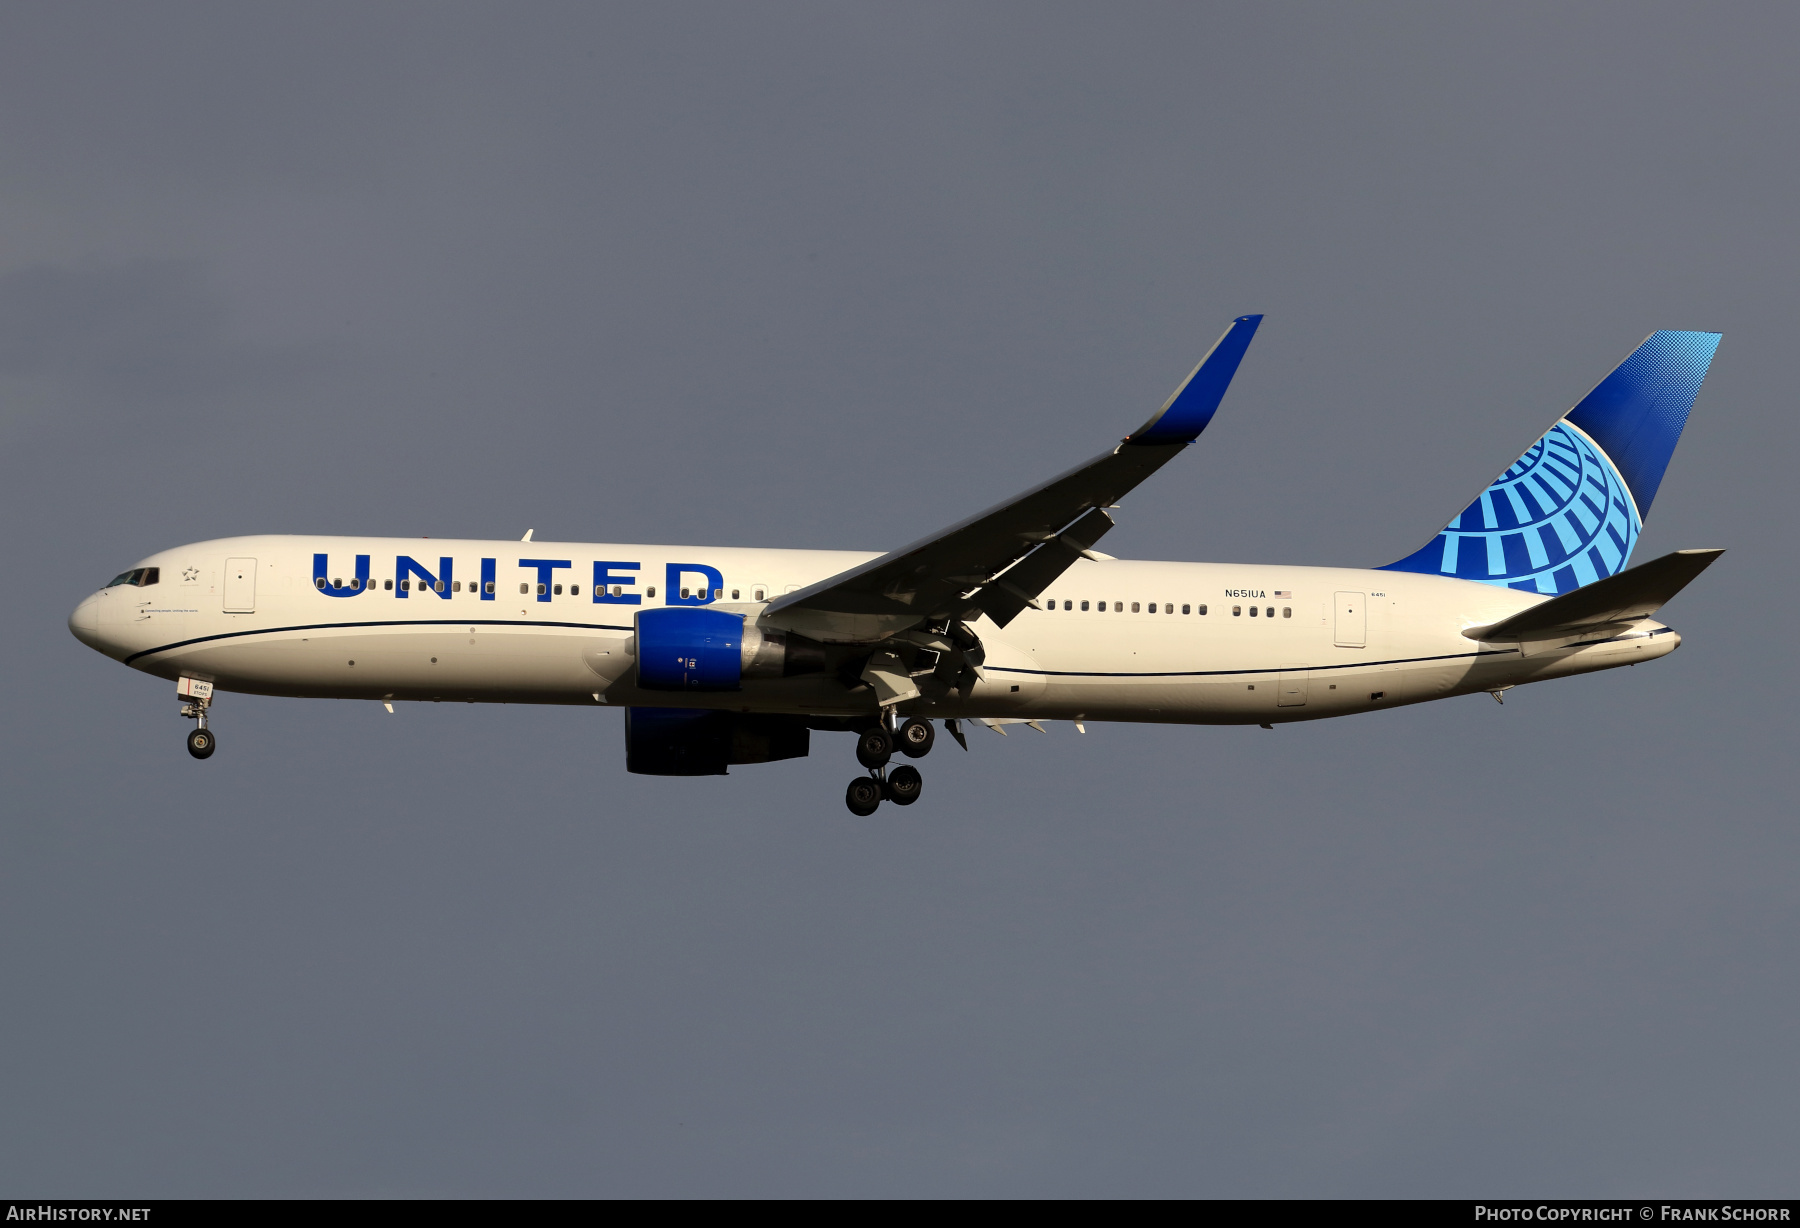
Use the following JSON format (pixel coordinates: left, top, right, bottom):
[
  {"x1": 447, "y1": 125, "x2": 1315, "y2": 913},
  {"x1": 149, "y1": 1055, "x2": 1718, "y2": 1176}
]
[{"x1": 68, "y1": 315, "x2": 1723, "y2": 816}]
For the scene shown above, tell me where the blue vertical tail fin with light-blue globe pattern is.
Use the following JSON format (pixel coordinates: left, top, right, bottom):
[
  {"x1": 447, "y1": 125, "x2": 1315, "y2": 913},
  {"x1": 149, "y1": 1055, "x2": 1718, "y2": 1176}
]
[{"x1": 1382, "y1": 330, "x2": 1719, "y2": 592}]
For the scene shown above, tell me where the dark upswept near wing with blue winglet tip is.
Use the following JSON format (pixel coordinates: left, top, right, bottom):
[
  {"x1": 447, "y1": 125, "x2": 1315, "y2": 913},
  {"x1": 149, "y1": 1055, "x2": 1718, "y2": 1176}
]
[{"x1": 761, "y1": 315, "x2": 1262, "y2": 643}]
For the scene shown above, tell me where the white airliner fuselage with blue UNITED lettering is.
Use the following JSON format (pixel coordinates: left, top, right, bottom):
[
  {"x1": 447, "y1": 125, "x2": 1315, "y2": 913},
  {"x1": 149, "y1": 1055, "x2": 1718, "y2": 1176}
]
[{"x1": 70, "y1": 537, "x2": 1679, "y2": 724}]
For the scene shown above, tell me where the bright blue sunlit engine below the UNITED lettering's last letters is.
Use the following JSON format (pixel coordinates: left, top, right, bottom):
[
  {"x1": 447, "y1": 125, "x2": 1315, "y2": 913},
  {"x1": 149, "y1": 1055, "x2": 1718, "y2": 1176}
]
[{"x1": 635, "y1": 605, "x2": 826, "y2": 691}]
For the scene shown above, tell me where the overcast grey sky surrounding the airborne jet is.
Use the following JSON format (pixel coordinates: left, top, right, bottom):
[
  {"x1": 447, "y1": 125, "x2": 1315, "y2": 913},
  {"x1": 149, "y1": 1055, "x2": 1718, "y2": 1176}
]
[{"x1": 0, "y1": 4, "x2": 1800, "y2": 1197}]
